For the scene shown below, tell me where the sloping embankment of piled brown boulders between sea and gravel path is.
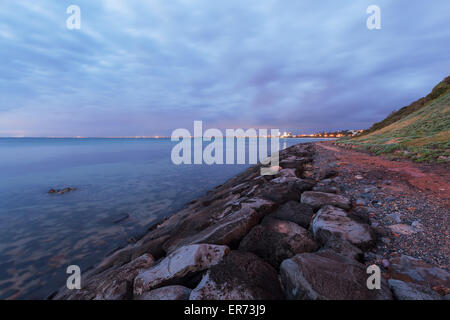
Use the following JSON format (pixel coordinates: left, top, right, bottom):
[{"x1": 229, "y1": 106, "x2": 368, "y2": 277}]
[{"x1": 52, "y1": 143, "x2": 450, "y2": 300}]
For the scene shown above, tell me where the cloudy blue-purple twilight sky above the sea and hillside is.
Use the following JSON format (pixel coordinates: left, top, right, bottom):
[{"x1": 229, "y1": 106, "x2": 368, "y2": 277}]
[{"x1": 0, "y1": 0, "x2": 450, "y2": 137}]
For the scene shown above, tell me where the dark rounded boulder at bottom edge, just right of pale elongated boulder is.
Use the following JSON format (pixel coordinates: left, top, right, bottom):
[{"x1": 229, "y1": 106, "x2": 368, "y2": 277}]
[{"x1": 190, "y1": 251, "x2": 284, "y2": 300}]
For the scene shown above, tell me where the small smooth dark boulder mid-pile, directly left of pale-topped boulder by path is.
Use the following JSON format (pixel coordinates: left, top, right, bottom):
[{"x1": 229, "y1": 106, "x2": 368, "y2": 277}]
[{"x1": 270, "y1": 201, "x2": 314, "y2": 229}]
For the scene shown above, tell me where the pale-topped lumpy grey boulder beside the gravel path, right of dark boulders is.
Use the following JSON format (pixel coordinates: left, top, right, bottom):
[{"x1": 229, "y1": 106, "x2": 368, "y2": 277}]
[{"x1": 312, "y1": 205, "x2": 376, "y2": 250}]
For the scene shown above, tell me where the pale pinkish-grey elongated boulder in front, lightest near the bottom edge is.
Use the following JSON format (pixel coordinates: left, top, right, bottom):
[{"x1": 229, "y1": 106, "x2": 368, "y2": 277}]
[{"x1": 134, "y1": 244, "x2": 229, "y2": 296}]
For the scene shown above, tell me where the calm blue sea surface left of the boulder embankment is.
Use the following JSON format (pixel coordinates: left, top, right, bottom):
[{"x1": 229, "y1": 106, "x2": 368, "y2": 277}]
[{"x1": 0, "y1": 138, "x2": 326, "y2": 299}]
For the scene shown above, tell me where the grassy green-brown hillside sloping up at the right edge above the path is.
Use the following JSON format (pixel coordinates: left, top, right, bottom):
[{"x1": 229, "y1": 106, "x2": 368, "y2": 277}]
[{"x1": 337, "y1": 77, "x2": 450, "y2": 162}]
